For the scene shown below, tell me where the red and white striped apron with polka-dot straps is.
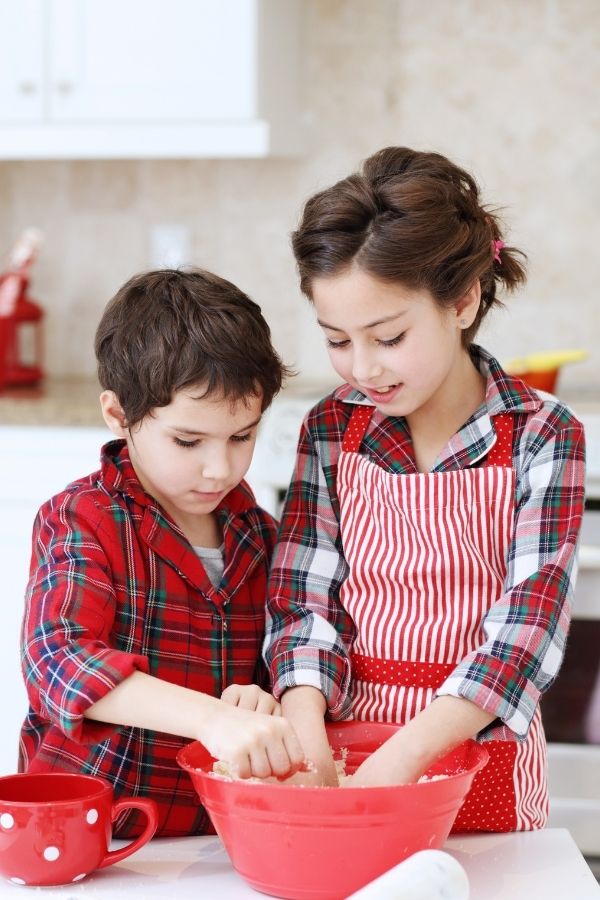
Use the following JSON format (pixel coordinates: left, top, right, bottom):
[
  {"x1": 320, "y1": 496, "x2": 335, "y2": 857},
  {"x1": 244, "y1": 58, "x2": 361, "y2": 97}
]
[{"x1": 337, "y1": 406, "x2": 548, "y2": 832}]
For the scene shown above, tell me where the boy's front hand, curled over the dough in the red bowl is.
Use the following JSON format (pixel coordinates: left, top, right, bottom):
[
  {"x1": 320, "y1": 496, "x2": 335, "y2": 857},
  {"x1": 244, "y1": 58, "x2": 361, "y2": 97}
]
[{"x1": 198, "y1": 700, "x2": 305, "y2": 778}]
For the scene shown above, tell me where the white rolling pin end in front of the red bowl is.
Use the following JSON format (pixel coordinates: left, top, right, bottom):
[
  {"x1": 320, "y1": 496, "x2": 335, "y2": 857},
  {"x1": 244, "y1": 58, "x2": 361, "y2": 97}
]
[{"x1": 347, "y1": 850, "x2": 469, "y2": 900}]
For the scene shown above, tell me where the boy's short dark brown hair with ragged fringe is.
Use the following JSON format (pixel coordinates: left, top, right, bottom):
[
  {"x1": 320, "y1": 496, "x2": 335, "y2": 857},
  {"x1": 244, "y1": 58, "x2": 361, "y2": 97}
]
[{"x1": 94, "y1": 269, "x2": 290, "y2": 428}]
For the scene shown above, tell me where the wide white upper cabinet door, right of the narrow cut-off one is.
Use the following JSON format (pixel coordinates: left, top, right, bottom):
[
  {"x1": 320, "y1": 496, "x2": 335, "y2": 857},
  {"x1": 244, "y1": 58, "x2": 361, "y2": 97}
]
[{"x1": 49, "y1": 0, "x2": 257, "y2": 123}]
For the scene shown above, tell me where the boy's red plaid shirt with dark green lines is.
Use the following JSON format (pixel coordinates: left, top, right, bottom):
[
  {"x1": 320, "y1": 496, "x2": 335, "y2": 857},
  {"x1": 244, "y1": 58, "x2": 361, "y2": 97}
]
[{"x1": 20, "y1": 441, "x2": 276, "y2": 837}]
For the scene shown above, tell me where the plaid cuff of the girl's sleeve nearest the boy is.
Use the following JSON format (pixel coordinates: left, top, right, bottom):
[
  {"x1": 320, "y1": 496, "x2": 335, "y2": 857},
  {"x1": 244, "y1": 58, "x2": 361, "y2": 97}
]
[{"x1": 270, "y1": 646, "x2": 352, "y2": 721}]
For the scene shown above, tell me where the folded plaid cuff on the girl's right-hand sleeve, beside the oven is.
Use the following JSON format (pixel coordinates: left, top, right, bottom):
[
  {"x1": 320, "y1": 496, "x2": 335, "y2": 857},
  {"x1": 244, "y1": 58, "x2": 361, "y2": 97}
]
[{"x1": 436, "y1": 653, "x2": 540, "y2": 741}]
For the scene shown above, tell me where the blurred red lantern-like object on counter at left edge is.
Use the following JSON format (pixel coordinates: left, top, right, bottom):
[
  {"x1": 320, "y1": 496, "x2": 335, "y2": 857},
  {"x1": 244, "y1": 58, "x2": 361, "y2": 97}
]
[{"x1": 0, "y1": 228, "x2": 44, "y2": 390}]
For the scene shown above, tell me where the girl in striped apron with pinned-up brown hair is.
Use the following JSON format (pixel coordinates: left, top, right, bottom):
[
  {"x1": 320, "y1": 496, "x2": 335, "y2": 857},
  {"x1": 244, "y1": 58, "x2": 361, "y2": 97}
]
[{"x1": 265, "y1": 147, "x2": 584, "y2": 831}]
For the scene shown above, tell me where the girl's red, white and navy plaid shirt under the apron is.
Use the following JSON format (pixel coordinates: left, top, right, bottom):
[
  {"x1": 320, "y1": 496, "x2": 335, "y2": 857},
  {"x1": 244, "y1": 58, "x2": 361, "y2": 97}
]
[{"x1": 264, "y1": 346, "x2": 585, "y2": 739}]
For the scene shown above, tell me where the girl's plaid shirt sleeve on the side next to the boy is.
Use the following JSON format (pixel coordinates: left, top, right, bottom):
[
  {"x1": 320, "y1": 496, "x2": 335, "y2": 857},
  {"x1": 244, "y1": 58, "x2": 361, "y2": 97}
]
[{"x1": 264, "y1": 421, "x2": 355, "y2": 719}]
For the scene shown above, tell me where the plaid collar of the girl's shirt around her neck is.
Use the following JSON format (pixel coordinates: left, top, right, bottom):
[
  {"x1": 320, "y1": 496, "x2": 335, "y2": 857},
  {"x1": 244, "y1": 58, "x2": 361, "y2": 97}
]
[{"x1": 333, "y1": 344, "x2": 543, "y2": 471}]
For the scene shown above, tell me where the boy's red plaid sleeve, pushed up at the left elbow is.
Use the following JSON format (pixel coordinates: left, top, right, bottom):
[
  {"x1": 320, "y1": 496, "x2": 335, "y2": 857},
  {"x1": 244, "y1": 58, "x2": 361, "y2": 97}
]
[{"x1": 22, "y1": 492, "x2": 149, "y2": 743}]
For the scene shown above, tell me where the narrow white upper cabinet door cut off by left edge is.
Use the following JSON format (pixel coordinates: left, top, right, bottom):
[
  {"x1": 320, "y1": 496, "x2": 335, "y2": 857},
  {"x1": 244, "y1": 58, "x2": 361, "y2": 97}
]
[{"x1": 0, "y1": 0, "x2": 45, "y2": 123}]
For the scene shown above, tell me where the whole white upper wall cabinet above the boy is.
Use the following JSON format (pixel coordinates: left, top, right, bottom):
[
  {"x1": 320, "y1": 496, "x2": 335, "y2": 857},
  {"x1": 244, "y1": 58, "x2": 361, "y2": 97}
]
[{"x1": 0, "y1": 0, "x2": 304, "y2": 159}]
